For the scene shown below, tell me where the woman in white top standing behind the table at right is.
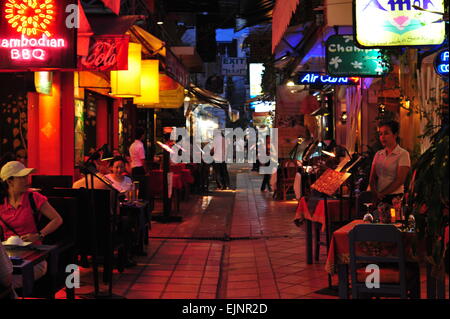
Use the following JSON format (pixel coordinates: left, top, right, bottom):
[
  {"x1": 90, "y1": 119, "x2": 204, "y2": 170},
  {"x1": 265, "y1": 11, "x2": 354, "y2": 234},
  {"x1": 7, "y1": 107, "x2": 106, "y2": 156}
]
[{"x1": 370, "y1": 121, "x2": 411, "y2": 204}]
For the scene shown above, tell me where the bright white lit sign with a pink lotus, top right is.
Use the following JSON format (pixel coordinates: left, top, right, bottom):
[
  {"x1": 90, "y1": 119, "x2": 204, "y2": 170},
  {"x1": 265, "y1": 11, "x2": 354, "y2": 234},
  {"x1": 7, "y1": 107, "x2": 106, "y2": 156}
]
[{"x1": 353, "y1": 0, "x2": 445, "y2": 47}]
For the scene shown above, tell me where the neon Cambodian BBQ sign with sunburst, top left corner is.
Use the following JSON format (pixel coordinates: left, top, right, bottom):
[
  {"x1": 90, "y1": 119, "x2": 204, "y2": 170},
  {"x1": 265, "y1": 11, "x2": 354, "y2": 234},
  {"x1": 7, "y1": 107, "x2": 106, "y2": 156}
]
[{"x1": 0, "y1": 0, "x2": 78, "y2": 70}]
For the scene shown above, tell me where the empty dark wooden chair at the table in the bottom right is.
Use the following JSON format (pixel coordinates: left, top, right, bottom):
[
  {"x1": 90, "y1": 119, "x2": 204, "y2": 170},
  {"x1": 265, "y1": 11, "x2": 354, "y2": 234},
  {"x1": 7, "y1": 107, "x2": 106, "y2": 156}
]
[{"x1": 349, "y1": 224, "x2": 420, "y2": 299}]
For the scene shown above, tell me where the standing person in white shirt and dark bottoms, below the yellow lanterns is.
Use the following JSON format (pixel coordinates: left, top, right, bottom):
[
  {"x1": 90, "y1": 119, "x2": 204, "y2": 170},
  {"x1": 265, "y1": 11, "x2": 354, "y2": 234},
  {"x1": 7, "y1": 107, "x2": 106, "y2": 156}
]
[{"x1": 129, "y1": 127, "x2": 147, "y2": 198}]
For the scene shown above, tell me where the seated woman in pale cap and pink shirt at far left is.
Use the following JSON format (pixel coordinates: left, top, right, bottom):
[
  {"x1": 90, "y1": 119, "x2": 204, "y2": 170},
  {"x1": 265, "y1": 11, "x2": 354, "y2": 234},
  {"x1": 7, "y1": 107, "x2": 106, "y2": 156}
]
[{"x1": 0, "y1": 161, "x2": 63, "y2": 288}]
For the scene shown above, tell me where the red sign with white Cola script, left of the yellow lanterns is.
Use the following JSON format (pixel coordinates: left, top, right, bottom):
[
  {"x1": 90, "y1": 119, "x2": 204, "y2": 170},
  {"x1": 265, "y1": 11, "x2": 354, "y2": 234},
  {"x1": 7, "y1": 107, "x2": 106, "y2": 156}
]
[{"x1": 79, "y1": 35, "x2": 130, "y2": 72}]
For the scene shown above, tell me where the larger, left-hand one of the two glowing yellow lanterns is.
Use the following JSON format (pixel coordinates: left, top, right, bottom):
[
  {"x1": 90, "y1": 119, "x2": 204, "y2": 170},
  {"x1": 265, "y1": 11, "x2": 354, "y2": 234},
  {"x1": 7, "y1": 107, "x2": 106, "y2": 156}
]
[{"x1": 111, "y1": 43, "x2": 142, "y2": 98}]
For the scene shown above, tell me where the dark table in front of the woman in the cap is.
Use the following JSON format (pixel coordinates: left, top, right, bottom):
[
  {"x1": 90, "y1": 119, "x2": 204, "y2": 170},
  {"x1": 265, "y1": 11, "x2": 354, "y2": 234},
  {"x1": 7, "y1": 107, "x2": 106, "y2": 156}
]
[{"x1": 5, "y1": 245, "x2": 58, "y2": 297}]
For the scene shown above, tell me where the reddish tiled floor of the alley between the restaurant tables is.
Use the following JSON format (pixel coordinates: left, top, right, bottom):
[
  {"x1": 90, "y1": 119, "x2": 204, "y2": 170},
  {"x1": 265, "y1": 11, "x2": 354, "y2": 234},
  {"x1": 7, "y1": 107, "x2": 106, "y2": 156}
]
[{"x1": 54, "y1": 167, "x2": 448, "y2": 299}]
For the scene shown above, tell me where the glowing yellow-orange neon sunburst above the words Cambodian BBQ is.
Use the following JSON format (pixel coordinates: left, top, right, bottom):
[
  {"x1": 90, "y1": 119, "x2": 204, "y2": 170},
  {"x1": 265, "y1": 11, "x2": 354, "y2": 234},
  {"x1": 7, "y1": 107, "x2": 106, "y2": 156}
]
[{"x1": 5, "y1": 0, "x2": 56, "y2": 37}]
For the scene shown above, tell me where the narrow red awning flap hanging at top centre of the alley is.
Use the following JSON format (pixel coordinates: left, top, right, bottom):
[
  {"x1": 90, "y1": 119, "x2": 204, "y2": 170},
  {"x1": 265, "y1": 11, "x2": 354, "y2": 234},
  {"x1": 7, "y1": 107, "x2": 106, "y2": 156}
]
[{"x1": 272, "y1": 0, "x2": 300, "y2": 53}]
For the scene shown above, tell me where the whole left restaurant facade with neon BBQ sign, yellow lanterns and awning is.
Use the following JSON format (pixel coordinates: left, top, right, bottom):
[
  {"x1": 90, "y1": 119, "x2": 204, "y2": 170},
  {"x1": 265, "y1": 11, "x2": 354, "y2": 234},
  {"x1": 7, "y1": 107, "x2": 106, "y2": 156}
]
[{"x1": 0, "y1": 0, "x2": 189, "y2": 180}]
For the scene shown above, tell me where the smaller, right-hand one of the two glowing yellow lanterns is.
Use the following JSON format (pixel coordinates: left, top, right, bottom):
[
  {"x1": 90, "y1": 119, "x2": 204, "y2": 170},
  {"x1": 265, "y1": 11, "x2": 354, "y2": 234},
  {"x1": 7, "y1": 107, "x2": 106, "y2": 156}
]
[{"x1": 134, "y1": 60, "x2": 159, "y2": 107}]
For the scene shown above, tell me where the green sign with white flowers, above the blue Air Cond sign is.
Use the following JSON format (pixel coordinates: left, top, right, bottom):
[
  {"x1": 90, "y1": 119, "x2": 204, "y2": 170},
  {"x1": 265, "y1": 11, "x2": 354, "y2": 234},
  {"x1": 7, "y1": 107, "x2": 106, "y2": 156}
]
[{"x1": 326, "y1": 34, "x2": 389, "y2": 77}]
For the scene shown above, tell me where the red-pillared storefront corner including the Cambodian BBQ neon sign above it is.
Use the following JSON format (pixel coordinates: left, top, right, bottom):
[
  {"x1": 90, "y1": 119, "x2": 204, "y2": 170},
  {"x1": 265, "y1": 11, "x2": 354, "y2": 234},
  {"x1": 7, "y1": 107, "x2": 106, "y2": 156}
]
[{"x1": 0, "y1": 0, "x2": 77, "y2": 175}]
